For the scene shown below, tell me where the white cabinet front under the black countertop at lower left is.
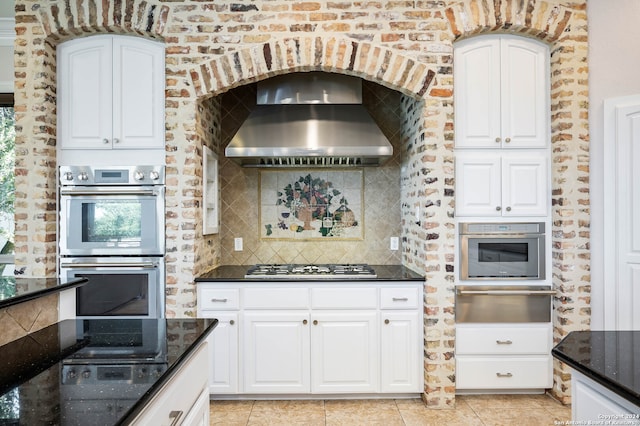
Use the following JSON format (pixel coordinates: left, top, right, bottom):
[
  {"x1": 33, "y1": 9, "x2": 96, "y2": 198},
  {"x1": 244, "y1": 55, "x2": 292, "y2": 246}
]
[{"x1": 132, "y1": 341, "x2": 210, "y2": 426}]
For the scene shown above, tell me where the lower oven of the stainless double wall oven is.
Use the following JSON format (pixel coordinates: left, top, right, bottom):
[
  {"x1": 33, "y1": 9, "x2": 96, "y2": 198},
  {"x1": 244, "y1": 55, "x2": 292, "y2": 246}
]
[{"x1": 60, "y1": 256, "x2": 165, "y2": 318}]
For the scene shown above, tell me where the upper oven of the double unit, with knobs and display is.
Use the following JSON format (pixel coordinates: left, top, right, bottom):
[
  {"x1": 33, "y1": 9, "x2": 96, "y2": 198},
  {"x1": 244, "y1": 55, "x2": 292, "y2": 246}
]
[{"x1": 59, "y1": 166, "x2": 165, "y2": 256}]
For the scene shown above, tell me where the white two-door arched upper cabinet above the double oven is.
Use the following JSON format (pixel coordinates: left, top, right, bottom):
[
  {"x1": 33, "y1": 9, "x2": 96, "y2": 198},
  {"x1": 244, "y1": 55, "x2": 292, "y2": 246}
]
[{"x1": 58, "y1": 36, "x2": 165, "y2": 149}]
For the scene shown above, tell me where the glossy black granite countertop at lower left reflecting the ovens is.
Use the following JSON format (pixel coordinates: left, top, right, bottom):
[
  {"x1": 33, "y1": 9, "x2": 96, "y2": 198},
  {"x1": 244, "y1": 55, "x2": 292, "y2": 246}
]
[{"x1": 0, "y1": 319, "x2": 218, "y2": 426}]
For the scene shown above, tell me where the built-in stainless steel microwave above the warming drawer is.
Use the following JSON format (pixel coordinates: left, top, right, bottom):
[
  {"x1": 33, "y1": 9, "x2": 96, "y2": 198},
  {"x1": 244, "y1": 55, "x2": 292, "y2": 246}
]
[{"x1": 459, "y1": 222, "x2": 545, "y2": 280}]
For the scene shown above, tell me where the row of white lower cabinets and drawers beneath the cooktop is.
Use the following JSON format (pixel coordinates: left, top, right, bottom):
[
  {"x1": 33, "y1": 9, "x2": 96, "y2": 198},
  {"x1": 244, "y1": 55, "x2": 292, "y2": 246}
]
[{"x1": 198, "y1": 281, "x2": 424, "y2": 397}]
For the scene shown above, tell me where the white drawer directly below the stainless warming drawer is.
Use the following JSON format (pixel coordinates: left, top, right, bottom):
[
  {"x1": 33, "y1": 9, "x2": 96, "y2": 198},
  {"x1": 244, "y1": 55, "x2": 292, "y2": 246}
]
[{"x1": 456, "y1": 325, "x2": 551, "y2": 355}]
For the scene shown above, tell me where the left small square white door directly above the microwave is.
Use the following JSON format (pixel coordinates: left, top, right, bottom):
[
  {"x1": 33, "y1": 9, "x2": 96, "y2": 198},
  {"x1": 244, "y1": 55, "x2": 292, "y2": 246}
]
[{"x1": 455, "y1": 152, "x2": 502, "y2": 216}]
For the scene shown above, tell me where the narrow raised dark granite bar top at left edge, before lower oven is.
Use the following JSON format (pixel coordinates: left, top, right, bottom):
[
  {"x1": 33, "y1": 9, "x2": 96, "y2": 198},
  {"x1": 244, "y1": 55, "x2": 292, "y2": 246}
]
[{"x1": 0, "y1": 277, "x2": 88, "y2": 309}]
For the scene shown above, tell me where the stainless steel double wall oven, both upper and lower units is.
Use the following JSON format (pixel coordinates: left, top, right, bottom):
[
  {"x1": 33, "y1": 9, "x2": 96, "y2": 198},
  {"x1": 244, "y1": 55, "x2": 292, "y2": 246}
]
[{"x1": 59, "y1": 166, "x2": 165, "y2": 319}]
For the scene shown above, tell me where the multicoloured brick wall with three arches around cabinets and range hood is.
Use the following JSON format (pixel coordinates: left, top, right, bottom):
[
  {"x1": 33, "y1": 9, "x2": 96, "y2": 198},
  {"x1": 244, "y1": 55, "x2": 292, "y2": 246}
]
[{"x1": 15, "y1": 0, "x2": 590, "y2": 407}]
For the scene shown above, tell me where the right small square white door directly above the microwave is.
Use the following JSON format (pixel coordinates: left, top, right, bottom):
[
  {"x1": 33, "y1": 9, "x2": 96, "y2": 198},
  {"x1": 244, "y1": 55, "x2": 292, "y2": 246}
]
[{"x1": 502, "y1": 153, "x2": 551, "y2": 216}]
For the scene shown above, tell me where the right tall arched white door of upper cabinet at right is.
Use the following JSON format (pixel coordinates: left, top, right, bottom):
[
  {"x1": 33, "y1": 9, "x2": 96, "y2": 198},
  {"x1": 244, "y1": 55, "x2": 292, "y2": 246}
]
[{"x1": 500, "y1": 36, "x2": 550, "y2": 148}]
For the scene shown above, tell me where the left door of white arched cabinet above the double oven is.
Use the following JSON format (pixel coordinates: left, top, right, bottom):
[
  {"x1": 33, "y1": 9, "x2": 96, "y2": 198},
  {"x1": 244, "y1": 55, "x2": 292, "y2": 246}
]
[{"x1": 58, "y1": 36, "x2": 113, "y2": 149}]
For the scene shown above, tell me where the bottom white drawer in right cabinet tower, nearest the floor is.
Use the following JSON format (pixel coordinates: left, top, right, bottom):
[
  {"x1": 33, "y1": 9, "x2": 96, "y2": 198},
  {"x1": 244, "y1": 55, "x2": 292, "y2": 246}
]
[{"x1": 456, "y1": 355, "x2": 553, "y2": 389}]
